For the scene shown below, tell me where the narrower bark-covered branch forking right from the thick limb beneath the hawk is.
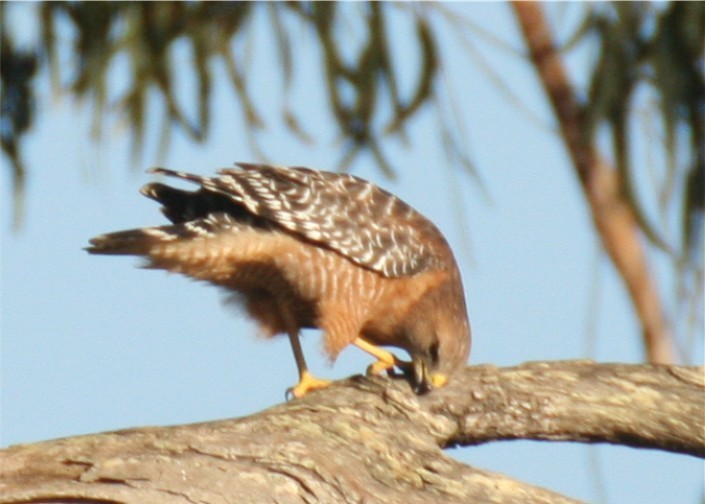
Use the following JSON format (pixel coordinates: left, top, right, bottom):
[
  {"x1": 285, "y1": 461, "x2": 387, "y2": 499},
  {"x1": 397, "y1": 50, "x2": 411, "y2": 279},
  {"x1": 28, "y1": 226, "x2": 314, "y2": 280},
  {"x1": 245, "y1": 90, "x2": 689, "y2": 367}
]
[{"x1": 421, "y1": 361, "x2": 705, "y2": 457}]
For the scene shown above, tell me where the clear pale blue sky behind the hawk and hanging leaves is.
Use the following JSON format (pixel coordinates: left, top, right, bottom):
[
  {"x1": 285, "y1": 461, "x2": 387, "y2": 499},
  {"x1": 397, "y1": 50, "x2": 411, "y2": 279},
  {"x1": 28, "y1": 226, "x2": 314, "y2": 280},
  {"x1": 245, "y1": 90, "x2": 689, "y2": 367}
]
[{"x1": 0, "y1": 3, "x2": 703, "y2": 503}]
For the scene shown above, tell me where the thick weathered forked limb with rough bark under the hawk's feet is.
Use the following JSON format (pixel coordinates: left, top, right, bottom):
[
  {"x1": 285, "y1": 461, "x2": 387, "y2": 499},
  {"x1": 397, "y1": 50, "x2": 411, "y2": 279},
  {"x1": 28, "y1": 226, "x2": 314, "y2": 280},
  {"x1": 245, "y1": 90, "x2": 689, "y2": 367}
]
[{"x1": 0, "y1": 361, "x2": 705, "y2": 503}]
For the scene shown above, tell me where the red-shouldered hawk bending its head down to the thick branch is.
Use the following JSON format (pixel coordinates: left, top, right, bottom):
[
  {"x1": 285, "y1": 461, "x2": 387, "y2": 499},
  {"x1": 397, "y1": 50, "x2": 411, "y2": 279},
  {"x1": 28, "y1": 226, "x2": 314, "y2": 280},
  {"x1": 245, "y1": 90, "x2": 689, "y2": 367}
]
[{"x1": 87, "y1": 163, "x2": 470, "y2": 397}]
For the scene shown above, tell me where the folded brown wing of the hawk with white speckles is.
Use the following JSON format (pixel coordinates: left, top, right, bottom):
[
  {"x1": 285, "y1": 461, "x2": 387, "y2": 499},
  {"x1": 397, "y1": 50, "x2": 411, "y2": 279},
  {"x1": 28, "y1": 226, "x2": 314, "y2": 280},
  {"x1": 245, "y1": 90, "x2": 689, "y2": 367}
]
[{"x1": 152, "y1": 163, "x2": 447, "y2": 277}]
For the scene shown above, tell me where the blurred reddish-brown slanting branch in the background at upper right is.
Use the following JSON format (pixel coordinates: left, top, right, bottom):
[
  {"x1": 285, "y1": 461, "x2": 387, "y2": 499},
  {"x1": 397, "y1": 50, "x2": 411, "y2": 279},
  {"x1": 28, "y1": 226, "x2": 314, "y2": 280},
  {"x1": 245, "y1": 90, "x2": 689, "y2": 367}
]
[{"x1": 512, "y1": 1, "x2": 675, "y2": 364}]
